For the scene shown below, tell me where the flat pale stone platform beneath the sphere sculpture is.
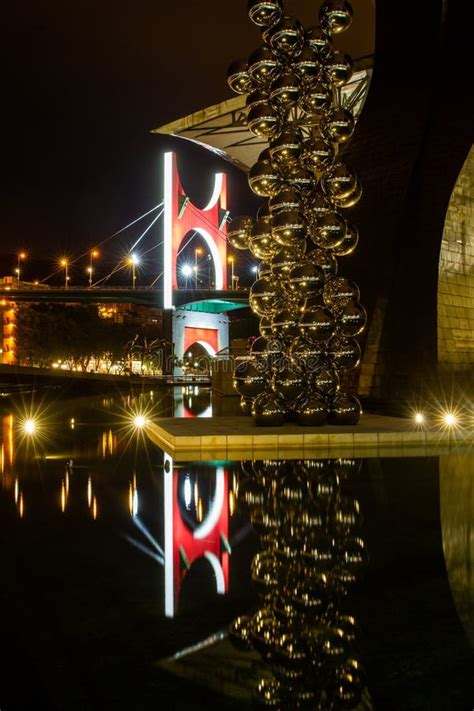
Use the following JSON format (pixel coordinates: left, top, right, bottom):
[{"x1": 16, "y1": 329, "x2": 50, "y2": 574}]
[{"x1": 147, "y1": 415, "x2": 474, "y2": 461}]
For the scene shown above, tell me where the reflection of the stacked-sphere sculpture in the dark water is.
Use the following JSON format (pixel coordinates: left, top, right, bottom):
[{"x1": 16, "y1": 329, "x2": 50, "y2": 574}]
[{"x1": 229, "y1": 460, "x2": 370, "y2": 709}]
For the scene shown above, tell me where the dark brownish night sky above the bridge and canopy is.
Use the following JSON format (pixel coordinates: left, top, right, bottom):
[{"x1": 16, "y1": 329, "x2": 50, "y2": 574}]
[{"x1": 0, "y1": 0, "x2": 373, "y2": 280}]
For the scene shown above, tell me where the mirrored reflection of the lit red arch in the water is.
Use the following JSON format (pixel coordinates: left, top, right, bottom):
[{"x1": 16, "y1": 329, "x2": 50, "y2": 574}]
[{"x1": 163, "y1": 454, "x2": 230, "y2": 617}]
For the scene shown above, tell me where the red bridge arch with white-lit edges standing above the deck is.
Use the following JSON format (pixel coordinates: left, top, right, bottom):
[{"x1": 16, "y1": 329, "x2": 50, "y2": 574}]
[{"x1": 163, "y1": 152, "x2": 229, "y2": 309}]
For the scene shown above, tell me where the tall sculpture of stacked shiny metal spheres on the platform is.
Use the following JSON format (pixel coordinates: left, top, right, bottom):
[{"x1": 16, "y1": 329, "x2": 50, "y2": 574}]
[{"x1": 228, "y1": 0, "x2": 367, "y2": 426}]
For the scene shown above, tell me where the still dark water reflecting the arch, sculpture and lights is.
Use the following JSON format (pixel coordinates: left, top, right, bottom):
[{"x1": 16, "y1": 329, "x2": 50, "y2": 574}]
[{"x1": 0, "y1": 389, "x2": 474, "y2": 711}]
